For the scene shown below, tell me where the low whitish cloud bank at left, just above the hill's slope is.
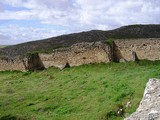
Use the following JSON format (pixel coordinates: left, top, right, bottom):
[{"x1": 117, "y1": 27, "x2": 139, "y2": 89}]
[{"x1": 0, "y1": 25, "x2": 66, "y2": 45}]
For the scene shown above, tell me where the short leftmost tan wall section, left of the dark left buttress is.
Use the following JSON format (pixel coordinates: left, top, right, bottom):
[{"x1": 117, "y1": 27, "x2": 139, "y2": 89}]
[{"x1": 0, "y1": 58, "x2": 27, "y2": 71}]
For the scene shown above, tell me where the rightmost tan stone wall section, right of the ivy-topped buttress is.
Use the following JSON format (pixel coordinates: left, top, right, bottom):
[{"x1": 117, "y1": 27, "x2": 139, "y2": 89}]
[{"x1": 114, "y1": 38, "x2": 160, "y2": 61}]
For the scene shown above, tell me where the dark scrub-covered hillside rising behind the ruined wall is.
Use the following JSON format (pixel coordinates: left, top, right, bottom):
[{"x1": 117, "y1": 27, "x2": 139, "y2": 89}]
[{"x1": 0, "y1": 24, "x2": 160, "y2": 57}]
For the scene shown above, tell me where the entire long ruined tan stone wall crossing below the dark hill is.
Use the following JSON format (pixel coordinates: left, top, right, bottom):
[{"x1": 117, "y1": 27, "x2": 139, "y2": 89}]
[{"x1": 0, "y1": 38, "x2": 160, "y2": 71}]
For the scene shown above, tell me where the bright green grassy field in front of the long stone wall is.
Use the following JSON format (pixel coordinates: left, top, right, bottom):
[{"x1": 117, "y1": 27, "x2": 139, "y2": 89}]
[{"x1": 0, "y1": 61, "x2": 160, "y2": 120}]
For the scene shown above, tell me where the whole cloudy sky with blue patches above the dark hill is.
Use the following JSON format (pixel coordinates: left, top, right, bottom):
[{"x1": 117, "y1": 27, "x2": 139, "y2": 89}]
[{"x1": 0, "y1": 0, "x2": 160, "y2": 45}]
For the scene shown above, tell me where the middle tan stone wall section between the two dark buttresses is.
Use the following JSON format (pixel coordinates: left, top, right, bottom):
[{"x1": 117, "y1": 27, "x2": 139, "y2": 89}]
[{"x1": 39, "y1": 42, "x2": 112, "y2": 69}]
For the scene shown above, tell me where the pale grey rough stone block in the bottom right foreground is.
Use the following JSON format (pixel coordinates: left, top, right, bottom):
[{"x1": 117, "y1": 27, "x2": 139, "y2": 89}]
[{"x1": 125, "y1": 79, "x2": 160, "y2": 120}]
